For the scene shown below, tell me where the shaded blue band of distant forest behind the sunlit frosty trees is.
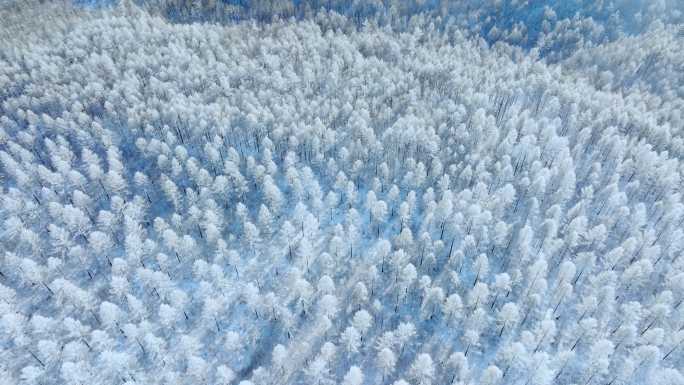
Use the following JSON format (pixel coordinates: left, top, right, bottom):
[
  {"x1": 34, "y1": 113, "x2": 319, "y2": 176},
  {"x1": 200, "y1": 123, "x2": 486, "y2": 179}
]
[{"x1": 139, "y1": 0, "x2": 684, "y2": 61}]
